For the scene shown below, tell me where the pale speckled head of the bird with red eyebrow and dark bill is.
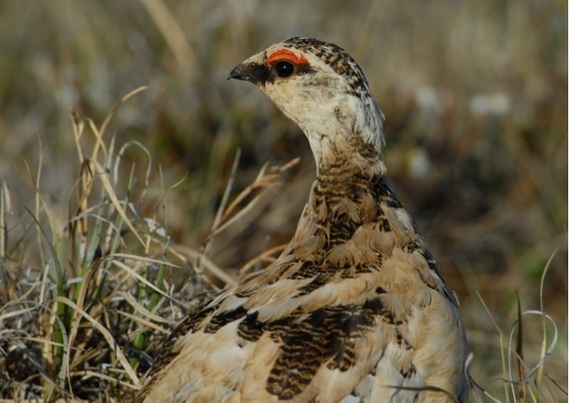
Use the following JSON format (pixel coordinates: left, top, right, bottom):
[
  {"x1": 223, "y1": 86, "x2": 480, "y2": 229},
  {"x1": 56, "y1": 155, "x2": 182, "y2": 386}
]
[{"x1": 228, "y1": 37, "x2": 384, "y2": 172}]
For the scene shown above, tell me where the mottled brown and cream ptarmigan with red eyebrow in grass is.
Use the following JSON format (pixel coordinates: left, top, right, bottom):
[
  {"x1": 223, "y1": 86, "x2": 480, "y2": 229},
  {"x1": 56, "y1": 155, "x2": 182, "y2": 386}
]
[{"x1": 135, "y1": 37, "x2": 469, "y2": 403}]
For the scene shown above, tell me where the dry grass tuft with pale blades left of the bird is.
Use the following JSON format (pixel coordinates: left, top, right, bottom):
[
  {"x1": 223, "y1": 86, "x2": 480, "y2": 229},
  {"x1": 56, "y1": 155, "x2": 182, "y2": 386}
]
[{"x1": 0, "y1": 87, "x2": 298, "y2": 400}]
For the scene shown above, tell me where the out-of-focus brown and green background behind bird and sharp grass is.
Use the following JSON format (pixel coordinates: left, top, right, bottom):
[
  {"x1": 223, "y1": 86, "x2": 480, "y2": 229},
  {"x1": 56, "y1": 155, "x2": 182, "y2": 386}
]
[{"x1": 0, "y1": 0, "x2": 568, "y2": 396}]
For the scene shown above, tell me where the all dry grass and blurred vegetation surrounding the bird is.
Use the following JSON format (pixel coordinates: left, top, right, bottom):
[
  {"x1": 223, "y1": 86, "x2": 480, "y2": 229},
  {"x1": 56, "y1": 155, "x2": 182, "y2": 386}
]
[{"x1": 0, "y1": 0, "x2": 568, "y2": 402}]
